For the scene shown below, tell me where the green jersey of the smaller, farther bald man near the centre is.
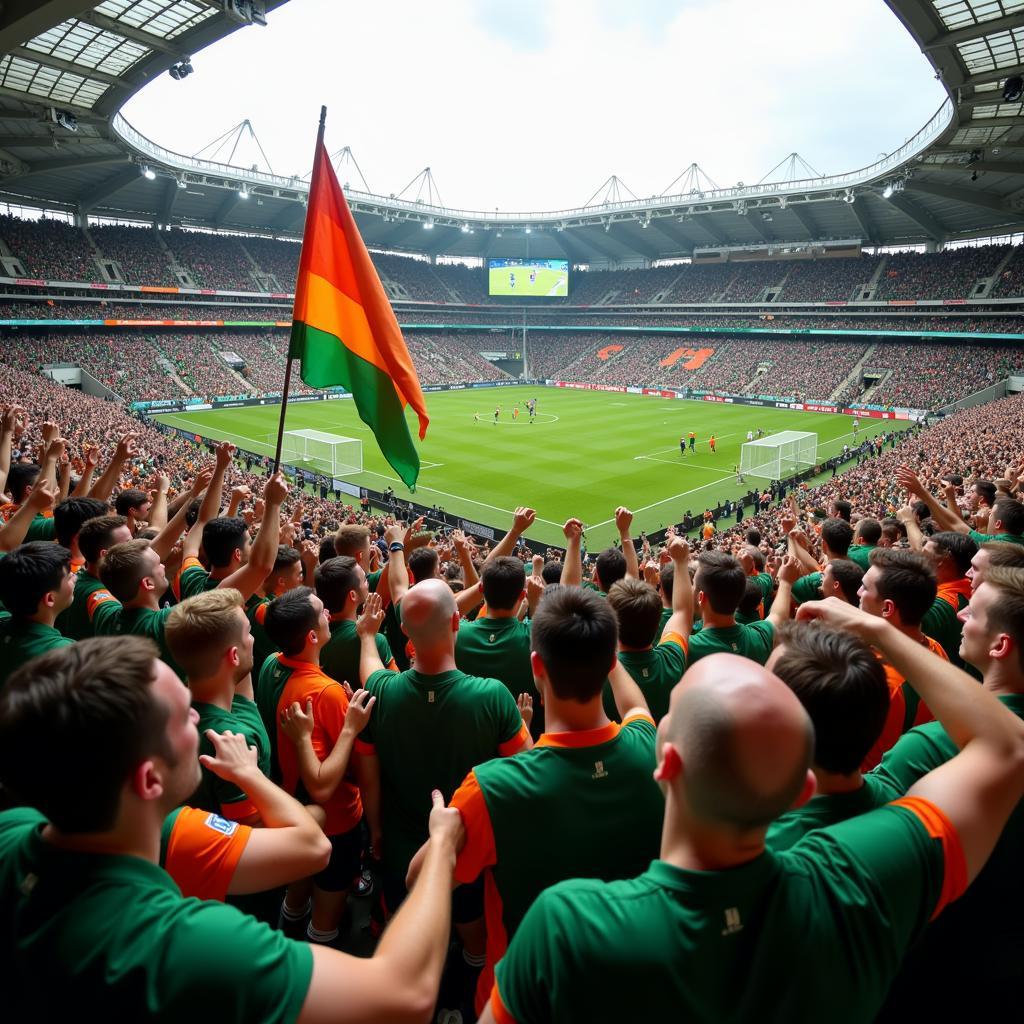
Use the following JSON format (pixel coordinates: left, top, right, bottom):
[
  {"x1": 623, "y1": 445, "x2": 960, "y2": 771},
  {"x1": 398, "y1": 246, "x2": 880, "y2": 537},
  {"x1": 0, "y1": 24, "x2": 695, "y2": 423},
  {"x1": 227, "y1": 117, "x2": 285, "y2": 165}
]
[{"x1": 355, "y1": 669, "x2": 529, "y2": 879}]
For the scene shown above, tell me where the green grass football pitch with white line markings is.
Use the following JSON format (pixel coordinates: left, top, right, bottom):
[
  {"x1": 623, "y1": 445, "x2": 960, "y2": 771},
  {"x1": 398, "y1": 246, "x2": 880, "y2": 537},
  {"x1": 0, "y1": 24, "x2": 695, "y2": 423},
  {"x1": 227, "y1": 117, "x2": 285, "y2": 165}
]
[{"x1": 157, "y1": 386, "x2": 907, "y2": 550}]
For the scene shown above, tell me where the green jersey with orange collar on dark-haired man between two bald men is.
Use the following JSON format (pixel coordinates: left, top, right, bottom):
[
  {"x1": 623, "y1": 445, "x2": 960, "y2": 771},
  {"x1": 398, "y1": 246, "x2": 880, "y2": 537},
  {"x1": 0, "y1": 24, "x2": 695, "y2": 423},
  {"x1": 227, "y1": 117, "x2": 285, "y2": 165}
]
[{"x1": 452, "y1": 715, "x2": 665, "y2": 1019}]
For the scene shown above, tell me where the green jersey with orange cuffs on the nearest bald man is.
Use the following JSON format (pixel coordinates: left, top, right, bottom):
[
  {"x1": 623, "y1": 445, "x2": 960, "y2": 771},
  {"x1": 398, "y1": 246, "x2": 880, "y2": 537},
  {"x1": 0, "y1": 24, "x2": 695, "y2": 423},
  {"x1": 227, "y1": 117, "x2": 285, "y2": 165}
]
[{"x1": 489, "y1": 799, "x2": 967, "y2": 1024}]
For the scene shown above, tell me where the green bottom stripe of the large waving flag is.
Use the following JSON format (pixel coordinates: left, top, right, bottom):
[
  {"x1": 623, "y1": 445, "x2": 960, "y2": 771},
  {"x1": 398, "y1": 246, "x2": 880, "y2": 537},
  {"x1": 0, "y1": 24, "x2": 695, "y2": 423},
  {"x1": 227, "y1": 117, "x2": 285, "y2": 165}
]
[{"x1": 288, "y1": 321, "x2": 420, "y2": 490}]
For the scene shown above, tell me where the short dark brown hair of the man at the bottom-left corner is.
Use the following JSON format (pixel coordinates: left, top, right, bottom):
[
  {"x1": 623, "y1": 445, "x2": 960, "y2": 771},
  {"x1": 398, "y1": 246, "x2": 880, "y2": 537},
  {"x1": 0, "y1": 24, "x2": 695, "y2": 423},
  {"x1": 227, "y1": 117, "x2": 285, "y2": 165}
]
[{"x1": 0, "y1": 636, "x2": 170, "y2": 834}]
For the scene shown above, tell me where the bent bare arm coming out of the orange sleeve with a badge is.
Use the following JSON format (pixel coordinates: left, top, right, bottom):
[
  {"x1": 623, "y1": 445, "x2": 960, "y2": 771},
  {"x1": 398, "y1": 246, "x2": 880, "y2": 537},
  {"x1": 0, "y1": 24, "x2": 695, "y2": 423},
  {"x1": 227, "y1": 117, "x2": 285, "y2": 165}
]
[{"x1": 200, "y1": 729, "x2": 331, "y2": 895}]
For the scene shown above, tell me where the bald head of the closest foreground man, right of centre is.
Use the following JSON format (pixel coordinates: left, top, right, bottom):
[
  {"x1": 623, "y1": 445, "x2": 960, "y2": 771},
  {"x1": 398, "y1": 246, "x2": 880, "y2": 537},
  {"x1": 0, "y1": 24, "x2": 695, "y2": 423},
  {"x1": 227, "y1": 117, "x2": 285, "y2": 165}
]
[{"x1": 662, "y1": 654, "x2": 814, "y2": 829}]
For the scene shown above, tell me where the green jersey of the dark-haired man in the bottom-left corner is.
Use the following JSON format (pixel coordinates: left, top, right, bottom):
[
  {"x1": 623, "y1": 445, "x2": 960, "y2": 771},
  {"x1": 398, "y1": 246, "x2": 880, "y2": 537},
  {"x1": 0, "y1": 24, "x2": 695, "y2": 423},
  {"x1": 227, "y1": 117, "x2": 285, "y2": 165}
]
[{"x1": 0, "y1": 808, "x2": 312, "y2": 1024}]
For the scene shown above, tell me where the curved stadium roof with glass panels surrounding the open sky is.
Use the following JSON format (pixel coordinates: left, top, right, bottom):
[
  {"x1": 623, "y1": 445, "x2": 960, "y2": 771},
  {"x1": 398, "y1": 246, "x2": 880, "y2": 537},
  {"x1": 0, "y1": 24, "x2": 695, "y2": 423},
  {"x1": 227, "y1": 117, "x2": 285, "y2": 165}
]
[{"x1": 0, "y1": 0, "x2": 1024, "y2": 263}]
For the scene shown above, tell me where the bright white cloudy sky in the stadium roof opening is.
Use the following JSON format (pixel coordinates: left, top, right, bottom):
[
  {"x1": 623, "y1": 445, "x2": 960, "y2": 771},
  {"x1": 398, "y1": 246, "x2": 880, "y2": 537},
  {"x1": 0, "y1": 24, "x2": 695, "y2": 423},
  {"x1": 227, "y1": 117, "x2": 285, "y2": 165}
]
[{"x1": 124, "y1": 0, "x2": 944, "y2": 212}]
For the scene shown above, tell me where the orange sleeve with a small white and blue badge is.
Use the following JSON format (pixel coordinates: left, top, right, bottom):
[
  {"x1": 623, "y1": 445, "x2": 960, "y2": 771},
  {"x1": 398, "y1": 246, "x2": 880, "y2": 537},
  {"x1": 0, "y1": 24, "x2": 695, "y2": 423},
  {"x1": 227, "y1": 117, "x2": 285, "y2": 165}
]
[{"x1": 160, "y1": 807, "x2": 252, "y2": 902}]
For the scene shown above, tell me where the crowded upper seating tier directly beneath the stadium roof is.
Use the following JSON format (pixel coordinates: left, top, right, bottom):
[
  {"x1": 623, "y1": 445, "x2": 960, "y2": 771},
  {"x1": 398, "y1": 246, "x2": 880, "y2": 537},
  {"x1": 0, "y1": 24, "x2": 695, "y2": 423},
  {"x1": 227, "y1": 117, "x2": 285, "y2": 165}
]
[{"x1": 0, "y1": 215, "x2": 1024, "y2": 306}]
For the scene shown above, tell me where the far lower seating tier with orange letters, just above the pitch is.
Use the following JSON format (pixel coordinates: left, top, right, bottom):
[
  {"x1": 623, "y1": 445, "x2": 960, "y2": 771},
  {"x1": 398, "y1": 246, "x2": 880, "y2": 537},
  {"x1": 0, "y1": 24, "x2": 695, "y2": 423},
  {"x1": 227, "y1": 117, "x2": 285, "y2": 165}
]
[{"x1": 0, "y1": 329, "x2": 1024, "y2": 410}]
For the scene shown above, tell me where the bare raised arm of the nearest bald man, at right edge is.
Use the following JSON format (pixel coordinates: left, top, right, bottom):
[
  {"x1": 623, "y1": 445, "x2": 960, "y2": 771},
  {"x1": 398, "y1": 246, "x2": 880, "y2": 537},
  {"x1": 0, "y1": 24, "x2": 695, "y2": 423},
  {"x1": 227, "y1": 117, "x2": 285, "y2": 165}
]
[{"x1": 798, "y1": 597, "x2": 1024, "y2": 881}]
